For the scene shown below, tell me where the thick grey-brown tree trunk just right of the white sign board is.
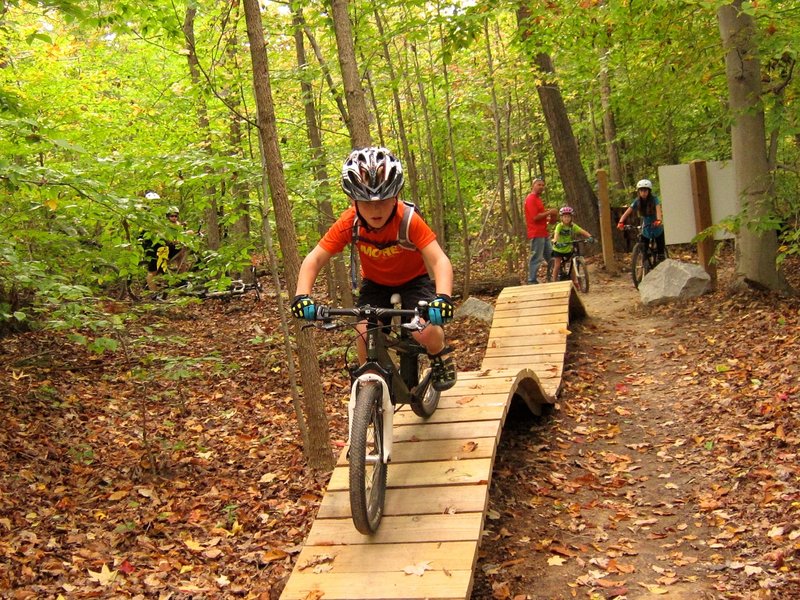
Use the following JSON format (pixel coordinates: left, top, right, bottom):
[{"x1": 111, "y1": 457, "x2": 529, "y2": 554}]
[{"x1": 717, "y1": 0, "x2": 788, "y2": 291}]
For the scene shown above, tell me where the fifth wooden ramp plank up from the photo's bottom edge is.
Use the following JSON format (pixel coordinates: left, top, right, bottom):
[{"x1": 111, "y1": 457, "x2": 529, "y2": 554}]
[{"x1": 328, "y1": 458, "x2": 492, "y2": 491}]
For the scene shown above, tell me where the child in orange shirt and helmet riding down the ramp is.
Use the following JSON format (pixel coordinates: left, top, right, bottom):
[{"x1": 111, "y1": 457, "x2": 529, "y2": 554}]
[{"x1": 292, "y1": 147, "x2": 456, "y2": 391}]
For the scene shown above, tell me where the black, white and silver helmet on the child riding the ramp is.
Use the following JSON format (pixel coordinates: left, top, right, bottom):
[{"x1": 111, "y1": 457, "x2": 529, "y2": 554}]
[{"x1": 342, "y1": 147, "x2": 403, "y2": 202}]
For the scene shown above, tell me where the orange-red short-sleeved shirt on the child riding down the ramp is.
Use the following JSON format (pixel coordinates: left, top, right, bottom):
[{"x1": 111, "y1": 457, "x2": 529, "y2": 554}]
[{"x1": 319, "y1": 202, "x2": 436, "y2": 286}]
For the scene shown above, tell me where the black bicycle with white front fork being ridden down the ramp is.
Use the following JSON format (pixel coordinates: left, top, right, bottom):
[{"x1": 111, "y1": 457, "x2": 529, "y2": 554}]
[{"x1": 307, "y1": 294, "x2": 440, "y2": 535}]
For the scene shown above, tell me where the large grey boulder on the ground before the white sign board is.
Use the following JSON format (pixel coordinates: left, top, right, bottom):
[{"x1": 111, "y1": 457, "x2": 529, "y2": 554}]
[{"x1": 639, "y1": 258, "x2": 711, "y2": 306}]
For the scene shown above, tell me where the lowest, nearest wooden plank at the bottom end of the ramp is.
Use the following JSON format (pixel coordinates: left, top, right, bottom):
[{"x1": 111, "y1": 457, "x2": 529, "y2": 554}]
[{"x1": 281, "y1": 569, "x2": 472, "y2": 600}]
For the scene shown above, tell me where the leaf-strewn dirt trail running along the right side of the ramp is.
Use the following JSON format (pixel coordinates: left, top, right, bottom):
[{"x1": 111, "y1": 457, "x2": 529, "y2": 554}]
[{"x1": 473, "y1": 269, "x2": 727, "y2": 599}]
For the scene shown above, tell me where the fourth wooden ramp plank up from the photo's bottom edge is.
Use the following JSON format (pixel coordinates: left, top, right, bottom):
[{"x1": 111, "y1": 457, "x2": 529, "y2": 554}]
[{"x1": 317, "y1": 486, "x2": 489, "y2": 519}]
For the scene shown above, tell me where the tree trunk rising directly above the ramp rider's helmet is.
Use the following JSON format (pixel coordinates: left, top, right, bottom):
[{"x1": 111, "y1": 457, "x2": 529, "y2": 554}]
[{"x1": 331, "y1": 0, "x2": 372, "y2": 148}]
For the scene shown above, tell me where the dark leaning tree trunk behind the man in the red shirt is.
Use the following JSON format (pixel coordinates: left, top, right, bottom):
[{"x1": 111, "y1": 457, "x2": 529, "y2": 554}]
[{"x1": 517, "y1": 6, "x2": 600, "y2": 231}]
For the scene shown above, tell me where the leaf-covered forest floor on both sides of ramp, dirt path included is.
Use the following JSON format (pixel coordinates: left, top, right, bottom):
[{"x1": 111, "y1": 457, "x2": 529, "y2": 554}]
[{"x1": 0, "y1": 245, "x2": 800, "y2": 600}]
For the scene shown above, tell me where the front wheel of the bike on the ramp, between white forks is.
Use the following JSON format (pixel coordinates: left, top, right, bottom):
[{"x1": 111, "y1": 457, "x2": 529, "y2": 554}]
[{"x1": 349, "y1": 382, "x2": 386, "y2": 535}]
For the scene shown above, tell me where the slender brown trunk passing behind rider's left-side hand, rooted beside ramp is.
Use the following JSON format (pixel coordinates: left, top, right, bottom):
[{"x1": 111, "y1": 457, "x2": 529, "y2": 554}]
[{"x1": 243, "y1": 0, "x2": 335, "y2": 471}]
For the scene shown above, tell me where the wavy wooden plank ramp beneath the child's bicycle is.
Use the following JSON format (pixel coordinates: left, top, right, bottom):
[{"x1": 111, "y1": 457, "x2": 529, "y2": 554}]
[{"x1": 281, "y1": 282, "x2": 585, "y2": 600}]
